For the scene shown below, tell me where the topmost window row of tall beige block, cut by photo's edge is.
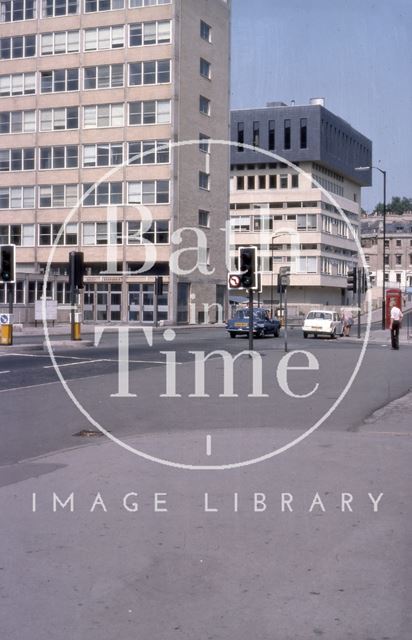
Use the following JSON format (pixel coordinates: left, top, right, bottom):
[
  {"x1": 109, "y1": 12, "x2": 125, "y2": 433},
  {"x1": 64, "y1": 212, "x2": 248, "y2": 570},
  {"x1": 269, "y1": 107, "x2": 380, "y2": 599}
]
[{"x1": 0, "y1": 0, "x2": 172, "y2": 22}]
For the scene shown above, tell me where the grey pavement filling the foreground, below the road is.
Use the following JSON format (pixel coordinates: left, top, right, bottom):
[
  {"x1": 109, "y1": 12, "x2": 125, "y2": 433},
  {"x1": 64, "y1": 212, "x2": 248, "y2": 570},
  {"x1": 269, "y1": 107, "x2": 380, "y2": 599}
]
[{"x1": 0, "y1": 384, "x2": 412, "y2": 640}]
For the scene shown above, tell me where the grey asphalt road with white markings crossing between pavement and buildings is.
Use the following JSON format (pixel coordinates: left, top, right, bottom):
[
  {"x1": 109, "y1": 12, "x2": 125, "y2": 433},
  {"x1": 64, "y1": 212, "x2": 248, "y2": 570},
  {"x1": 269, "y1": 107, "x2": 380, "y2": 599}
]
[{"x1": 0, "y1": 328, "x2": 412, "y2": 464}]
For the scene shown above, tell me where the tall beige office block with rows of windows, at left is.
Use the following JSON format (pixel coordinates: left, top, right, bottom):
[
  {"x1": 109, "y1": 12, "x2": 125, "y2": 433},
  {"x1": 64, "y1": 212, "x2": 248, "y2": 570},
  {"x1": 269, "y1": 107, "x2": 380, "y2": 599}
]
[{"x1": 0, "y1": 0, "x2": 230, "y2": 322}]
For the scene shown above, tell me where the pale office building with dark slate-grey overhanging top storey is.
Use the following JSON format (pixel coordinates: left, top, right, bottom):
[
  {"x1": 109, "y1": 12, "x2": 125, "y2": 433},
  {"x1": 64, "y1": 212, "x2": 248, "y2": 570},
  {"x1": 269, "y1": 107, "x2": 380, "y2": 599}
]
[{"x1": 230, "y1": 99, "x2": 372, "y2": 312}]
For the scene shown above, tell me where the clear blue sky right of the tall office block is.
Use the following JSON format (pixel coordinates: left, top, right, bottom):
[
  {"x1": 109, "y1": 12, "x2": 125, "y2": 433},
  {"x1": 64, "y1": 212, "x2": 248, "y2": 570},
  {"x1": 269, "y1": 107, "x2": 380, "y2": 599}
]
[{"x1": 232, "y1": 0, "x2": 412, "y2": 211}]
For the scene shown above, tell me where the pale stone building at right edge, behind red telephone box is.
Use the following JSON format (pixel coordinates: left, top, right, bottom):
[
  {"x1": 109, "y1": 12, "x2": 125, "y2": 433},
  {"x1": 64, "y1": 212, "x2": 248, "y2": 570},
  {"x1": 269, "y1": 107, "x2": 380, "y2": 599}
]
[{"x1": 361, "y1": 213, "x2": 412, "y2": 300}]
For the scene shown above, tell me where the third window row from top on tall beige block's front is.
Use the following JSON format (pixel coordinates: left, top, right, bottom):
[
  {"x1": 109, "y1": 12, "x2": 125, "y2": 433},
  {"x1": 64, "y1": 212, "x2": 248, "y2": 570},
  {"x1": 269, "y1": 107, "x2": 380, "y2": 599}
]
[{"x1": 0, "y1": 60, "x2": 171, "y2": 97}]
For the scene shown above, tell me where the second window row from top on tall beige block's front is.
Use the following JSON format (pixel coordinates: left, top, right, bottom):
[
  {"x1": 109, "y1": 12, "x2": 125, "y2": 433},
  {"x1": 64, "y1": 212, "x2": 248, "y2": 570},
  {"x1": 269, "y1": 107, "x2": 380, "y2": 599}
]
[{"x1": 0, "y1": 20, "x2": 172, "y2": 60}]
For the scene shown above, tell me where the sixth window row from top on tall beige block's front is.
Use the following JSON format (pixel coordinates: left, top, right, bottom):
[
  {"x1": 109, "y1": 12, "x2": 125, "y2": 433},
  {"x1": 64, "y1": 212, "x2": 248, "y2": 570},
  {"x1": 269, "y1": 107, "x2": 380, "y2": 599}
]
[{"x1": 0, "y1": 180, "x2": 170, "y2": 209}]
